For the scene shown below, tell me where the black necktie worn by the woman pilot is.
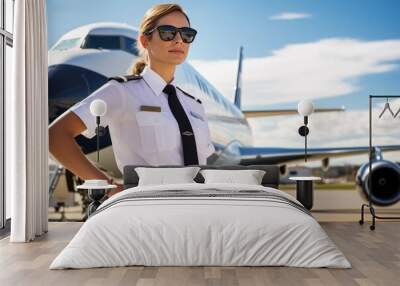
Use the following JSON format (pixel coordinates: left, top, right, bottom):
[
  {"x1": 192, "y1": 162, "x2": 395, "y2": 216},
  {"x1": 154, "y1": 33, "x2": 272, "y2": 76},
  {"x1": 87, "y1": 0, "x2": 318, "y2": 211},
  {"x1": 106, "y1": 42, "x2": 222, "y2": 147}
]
[{"x1": 163, "y1": 84, "x2": 199, "y2": 166}]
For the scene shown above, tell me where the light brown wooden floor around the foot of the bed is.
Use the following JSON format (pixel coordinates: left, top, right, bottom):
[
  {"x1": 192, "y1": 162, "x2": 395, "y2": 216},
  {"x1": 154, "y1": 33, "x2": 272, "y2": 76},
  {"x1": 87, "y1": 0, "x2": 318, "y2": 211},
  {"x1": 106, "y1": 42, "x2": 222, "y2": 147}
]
[{"x1": 0, "y1": 221, "x2": 400, "y2": 286}]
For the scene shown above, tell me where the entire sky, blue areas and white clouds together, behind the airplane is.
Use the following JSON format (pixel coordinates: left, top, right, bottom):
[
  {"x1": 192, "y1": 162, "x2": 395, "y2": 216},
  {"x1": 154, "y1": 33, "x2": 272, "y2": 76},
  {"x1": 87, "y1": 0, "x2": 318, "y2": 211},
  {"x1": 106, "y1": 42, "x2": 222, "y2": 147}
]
[{"x1": 47, "y1": 0, "x2": 400, "y2": 164}]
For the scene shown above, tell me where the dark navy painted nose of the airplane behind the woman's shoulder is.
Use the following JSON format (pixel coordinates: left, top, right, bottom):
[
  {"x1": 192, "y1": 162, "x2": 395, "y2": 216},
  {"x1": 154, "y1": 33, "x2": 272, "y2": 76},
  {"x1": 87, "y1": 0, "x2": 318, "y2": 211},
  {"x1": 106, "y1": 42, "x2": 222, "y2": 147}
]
[{"x1": 48, "y1": 64, "x2": 107, "y2": 124}]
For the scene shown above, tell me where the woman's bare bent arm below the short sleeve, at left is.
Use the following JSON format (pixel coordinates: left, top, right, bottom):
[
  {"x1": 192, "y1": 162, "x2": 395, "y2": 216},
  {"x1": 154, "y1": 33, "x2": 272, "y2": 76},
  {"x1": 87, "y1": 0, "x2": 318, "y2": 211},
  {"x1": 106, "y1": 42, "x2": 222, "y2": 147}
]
[{"x1": 49, "y1": 111, "x2": 108, "y2": 180}]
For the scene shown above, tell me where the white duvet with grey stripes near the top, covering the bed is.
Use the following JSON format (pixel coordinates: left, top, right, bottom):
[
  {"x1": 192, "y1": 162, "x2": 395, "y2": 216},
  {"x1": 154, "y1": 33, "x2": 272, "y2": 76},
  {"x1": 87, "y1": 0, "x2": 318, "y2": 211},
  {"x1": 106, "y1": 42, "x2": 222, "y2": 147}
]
[{"x1": 50, "y1": 183, "x2": 351, "y2": 269}]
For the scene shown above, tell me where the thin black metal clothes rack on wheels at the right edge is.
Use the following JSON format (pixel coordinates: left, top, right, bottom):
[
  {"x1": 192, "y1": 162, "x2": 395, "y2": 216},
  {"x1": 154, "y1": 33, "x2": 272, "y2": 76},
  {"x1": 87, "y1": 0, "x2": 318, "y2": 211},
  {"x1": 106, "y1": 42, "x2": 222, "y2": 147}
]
[{"x1": 359, "y1": 95, "x2": 400, "y2": 230}]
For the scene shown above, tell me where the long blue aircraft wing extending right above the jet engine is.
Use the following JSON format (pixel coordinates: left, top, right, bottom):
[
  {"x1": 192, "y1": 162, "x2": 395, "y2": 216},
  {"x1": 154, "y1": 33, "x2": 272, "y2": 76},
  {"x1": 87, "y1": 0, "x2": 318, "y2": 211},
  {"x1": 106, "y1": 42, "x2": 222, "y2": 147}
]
[{"x1": 238, "y1": 145, "x2": 400, "y2": 165}]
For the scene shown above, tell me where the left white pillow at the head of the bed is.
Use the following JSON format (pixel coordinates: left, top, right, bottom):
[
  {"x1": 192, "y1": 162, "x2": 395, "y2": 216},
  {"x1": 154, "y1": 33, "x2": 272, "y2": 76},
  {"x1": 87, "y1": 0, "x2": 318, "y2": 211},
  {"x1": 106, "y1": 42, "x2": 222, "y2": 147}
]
[{"x1": 135, "y1": 167, "x2": 200, "y2": 186}]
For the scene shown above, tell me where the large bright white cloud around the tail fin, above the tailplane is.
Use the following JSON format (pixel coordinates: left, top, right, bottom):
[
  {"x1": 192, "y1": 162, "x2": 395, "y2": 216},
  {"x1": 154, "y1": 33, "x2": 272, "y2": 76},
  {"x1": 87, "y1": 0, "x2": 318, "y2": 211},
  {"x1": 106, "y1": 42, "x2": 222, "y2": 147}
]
[{"x1": 190, "y1": 38, "x2": 400, "y2": 106}]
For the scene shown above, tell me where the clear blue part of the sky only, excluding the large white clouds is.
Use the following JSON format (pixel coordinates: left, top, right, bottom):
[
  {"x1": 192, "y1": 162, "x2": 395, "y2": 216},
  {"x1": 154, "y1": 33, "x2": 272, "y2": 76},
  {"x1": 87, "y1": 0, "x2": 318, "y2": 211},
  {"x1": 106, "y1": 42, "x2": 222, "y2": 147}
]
[{"x1": 47, "y1": 0, "x2": 400, "y2": 108}]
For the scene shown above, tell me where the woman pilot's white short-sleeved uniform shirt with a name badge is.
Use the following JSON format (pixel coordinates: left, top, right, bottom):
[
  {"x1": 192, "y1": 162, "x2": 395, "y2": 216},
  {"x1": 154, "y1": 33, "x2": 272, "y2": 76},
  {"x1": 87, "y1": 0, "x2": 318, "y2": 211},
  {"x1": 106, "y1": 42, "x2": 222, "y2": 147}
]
[{"x1": 69, "y1": 66, "x2": 215, "y2": 173}]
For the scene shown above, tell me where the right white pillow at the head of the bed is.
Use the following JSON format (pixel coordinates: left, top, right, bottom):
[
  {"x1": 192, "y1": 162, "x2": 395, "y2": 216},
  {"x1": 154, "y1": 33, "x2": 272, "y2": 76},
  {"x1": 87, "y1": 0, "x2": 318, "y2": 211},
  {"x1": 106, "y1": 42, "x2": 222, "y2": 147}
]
[{"x1": 200, "y1": 169, "x2": 266, "y2": 185}]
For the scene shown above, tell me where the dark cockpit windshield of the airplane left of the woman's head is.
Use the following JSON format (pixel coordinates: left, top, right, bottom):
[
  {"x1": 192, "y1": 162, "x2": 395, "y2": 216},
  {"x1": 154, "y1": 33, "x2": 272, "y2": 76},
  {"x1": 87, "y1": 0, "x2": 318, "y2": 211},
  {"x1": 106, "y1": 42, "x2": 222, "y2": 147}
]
[{"x1": 81, "y1": 35, "x2": 138, "y2": 56}]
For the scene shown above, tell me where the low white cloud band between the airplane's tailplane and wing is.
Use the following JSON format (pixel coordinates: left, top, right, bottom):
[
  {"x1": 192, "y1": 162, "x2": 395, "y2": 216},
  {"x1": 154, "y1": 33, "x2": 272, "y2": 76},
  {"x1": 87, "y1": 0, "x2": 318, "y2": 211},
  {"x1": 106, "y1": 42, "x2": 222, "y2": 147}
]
[{"x1": 249, "y1": 99, "x2": 400, "y2": 163}]
